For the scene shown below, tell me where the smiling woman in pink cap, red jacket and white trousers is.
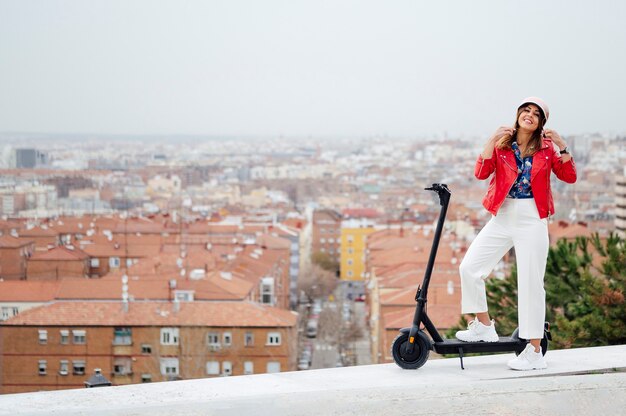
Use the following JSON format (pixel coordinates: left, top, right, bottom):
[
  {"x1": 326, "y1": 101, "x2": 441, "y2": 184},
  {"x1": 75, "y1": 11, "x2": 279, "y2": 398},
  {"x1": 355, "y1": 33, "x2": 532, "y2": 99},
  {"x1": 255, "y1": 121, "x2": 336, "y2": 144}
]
[{"x1": 456, "y1": 97, "x2": 576, "y2": 370}]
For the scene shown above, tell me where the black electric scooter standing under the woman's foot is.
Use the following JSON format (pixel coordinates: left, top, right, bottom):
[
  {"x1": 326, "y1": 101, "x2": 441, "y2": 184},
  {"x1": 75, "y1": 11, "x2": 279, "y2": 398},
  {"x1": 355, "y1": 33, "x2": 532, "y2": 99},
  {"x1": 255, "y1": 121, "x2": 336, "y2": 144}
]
[{"x1": 391, "y1": 183, "x2": 552, "y2": 370}]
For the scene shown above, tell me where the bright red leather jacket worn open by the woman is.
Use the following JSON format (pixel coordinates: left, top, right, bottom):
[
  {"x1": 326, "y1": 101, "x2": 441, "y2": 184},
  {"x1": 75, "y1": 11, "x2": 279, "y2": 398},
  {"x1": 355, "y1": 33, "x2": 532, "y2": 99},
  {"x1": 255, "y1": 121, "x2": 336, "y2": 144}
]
[{"x1": 474, "y1": 138, "x2": 576, "y2": 218}]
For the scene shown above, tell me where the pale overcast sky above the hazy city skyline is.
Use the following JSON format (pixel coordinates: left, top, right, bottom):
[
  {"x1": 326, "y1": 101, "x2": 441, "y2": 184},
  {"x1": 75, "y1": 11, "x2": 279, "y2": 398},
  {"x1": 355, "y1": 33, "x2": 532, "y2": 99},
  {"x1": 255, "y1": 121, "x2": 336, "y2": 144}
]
[{"x1": 0, "y1": 0, "x2": 626, "y2": 137}]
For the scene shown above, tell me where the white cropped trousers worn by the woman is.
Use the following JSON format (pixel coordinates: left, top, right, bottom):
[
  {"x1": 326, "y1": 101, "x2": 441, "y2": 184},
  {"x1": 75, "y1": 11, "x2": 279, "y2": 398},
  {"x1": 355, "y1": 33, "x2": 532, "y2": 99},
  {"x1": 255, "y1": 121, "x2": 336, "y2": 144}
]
[{"x1": 459, "y1": 198, "x2": 549, "y2": 339}]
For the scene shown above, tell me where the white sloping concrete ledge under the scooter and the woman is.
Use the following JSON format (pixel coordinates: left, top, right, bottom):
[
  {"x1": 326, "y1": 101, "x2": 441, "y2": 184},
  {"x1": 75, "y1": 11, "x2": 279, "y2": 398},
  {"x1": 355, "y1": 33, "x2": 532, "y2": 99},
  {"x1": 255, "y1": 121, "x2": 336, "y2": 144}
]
[{"x1": 0, "y1": 345, "x2": 626, "y2": 416}]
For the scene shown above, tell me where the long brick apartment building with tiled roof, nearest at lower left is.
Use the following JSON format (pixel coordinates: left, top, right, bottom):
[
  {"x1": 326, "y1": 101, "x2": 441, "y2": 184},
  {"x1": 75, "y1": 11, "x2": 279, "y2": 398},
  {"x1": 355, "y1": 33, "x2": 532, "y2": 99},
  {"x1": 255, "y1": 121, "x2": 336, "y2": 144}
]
[{"x1": 0, "y1": 302, "x2": 297, "y2": 394}]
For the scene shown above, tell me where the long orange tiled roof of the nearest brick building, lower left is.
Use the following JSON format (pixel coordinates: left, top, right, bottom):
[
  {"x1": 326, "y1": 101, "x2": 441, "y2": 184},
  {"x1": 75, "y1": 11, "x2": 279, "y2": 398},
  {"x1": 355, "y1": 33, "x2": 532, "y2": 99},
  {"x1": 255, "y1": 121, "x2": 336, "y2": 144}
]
[{"x1": 0, "y1": 302, "x2": 298, "y2": 327}]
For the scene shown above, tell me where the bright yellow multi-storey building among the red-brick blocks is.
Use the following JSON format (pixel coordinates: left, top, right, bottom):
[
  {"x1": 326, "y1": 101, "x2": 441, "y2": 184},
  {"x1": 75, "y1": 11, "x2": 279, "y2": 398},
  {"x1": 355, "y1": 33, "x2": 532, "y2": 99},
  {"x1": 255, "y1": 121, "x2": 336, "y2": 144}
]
[{"x1": 340, "y1": 219, "x2": 375, "y2": 282}]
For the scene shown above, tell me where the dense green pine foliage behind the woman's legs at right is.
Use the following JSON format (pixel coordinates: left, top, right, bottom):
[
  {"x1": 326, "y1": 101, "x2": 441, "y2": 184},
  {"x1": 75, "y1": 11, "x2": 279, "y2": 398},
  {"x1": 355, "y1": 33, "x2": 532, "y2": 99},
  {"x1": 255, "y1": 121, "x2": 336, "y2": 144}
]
[{"x1": 448, "y1": 234, "x2": 626, "y2": 348}]
